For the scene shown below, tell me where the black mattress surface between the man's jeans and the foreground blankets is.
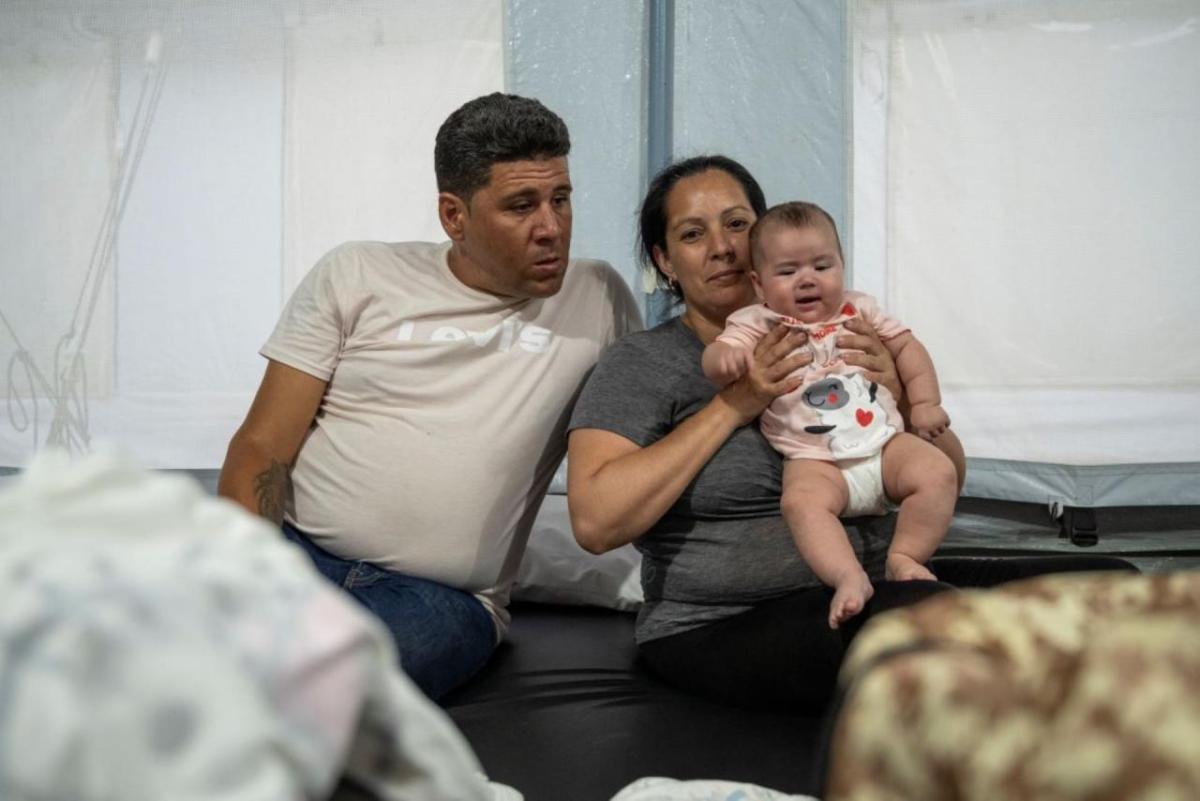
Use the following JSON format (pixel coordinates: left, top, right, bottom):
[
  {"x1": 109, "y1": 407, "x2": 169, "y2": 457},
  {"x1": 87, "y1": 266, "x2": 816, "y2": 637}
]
[{"x1": 443, "y1": 603, "x2": 823, "y2": 801}]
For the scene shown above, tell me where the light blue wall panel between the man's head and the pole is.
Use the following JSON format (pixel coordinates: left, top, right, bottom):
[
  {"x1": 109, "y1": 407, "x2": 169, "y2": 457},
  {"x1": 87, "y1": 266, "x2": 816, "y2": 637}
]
[{"x1": 505, "y1": 0, "x2": 646, "y2": 299}]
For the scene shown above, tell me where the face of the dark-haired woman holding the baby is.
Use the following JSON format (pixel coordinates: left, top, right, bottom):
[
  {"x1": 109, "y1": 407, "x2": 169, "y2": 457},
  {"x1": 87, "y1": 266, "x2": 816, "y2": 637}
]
[{"x1": 654, "y1": 169, "x2": 757, "y2": 326}]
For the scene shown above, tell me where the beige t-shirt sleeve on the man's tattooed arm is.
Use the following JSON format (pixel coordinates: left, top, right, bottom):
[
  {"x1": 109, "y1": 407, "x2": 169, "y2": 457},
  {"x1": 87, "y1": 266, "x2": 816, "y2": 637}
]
[{"x1": 258, "y1": 248, "x2": 346, "y2": 381}]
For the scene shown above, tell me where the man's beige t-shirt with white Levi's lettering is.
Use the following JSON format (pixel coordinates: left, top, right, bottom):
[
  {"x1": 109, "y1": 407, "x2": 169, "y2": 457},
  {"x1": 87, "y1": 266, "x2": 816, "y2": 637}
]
[{"x1": 260, "y1": 242, "x2": 641, "y2": 634}]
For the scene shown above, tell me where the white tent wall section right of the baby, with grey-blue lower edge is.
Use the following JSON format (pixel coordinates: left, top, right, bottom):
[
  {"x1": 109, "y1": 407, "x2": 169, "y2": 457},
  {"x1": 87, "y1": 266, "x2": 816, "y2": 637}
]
[{"x1": 852, "y1": 0, "x2": 1200, "y2": 506}]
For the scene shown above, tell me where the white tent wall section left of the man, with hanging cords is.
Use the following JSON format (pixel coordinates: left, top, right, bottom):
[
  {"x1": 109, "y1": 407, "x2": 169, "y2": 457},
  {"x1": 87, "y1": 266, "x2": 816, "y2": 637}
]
[{"x1": 0, "y1": 0, "x2": 504, "y2": 469}]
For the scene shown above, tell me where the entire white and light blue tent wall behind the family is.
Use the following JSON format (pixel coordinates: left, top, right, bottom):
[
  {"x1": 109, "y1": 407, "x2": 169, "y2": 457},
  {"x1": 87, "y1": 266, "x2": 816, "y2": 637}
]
[{"x1": 0, "y1": 0, "x2": 1200, "y2": 506}]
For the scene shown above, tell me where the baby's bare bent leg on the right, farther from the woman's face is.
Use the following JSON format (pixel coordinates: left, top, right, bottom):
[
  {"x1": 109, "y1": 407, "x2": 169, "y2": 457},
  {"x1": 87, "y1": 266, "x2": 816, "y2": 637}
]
[{"x1": 883, "y1": 434, "x2": 959, "y2": 580}]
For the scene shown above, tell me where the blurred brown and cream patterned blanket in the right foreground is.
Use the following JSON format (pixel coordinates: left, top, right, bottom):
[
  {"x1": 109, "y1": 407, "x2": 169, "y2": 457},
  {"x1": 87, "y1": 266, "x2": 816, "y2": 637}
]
[{"x1": 826, "y1": 572, "x2": 1200, "y2": 801}]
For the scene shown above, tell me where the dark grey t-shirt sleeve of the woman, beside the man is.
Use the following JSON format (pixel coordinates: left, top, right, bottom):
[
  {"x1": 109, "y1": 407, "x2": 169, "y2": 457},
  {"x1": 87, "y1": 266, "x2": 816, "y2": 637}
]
[{"x1": 569, "y1": 333, "x2": 672, "y2": 447}]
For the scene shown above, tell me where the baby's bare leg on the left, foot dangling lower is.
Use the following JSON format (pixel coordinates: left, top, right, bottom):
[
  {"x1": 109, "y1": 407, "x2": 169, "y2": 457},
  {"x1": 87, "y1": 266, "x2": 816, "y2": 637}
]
[{"x1": 782, "y1": 459, "x2": 875, "y2": 628}]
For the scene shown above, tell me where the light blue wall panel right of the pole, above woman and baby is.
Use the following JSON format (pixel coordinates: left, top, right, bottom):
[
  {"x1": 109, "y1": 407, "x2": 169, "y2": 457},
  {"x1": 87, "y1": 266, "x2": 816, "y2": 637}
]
[{"x1": 674, "y1": 0, "x2": 851, "y2": 255}]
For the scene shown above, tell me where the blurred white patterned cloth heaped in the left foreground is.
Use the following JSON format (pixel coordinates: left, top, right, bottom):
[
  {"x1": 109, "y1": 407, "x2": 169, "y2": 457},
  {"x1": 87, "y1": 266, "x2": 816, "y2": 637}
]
[{"x1": 0, "y1": 443, "x2": 501, "y2": 801}]
